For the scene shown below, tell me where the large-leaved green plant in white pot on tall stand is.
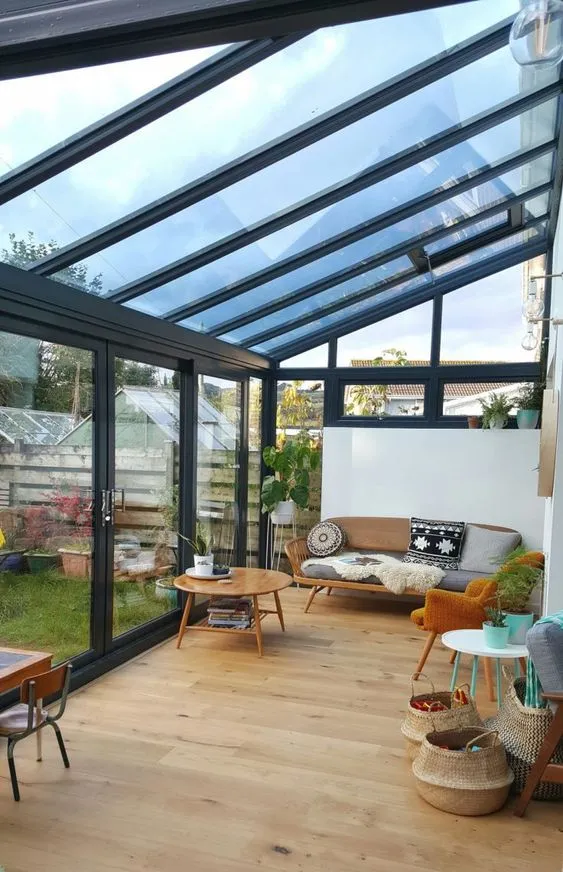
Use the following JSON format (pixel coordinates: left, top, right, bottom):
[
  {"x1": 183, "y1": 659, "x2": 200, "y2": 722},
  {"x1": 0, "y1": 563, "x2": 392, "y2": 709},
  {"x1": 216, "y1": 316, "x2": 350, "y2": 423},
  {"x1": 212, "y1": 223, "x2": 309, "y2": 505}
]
[{"x1": 260, "y1": 434, "x2": 320, "y2": 524}]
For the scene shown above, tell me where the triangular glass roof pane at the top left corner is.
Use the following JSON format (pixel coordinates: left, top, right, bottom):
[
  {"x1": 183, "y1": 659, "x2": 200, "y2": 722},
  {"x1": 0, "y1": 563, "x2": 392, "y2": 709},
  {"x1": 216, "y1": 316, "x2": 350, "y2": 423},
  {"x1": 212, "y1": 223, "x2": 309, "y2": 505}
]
[{"x1": 0, "y1": 46, "x2": 229, "y2": 173}]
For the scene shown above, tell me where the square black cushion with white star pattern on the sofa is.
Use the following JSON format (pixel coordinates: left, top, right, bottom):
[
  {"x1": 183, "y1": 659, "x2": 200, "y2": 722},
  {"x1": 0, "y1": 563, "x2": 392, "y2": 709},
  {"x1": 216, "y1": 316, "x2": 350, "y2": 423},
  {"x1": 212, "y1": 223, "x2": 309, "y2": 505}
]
[{"x1": 403, "y1": 518, "x2": 465, "y2": 571}]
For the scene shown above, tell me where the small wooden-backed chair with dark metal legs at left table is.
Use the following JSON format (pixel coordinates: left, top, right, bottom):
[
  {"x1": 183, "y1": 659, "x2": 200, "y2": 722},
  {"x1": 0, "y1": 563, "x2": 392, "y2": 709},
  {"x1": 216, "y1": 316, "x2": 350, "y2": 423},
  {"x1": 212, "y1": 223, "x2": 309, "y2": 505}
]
[{"x1": 0, "y1": 664, "x2": 71, "y2": 802}]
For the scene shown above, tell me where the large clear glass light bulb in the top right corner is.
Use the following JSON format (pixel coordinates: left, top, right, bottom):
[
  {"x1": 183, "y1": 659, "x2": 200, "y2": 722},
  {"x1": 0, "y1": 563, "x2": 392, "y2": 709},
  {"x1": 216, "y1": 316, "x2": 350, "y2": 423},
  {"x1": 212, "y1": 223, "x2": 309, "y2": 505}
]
[{"x1": 510, "y1": 0, "x2": 563, "y2": 67}]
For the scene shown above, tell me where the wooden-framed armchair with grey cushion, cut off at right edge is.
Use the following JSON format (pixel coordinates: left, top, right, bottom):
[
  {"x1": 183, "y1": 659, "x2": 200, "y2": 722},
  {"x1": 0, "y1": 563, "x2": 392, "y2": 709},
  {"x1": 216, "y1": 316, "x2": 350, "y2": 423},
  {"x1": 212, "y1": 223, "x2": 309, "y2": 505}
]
[{"x1": 514, "y1": 623, "x2": 563, "y2": 817}]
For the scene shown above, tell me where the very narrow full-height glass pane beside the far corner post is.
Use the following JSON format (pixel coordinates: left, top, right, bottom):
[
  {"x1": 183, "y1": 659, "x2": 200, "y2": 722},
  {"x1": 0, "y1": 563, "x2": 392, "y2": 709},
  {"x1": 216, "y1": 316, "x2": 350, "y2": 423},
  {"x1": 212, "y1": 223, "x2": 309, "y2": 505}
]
[{"x1": 246, "y1": 378, "x2": 262, "y2": 566}]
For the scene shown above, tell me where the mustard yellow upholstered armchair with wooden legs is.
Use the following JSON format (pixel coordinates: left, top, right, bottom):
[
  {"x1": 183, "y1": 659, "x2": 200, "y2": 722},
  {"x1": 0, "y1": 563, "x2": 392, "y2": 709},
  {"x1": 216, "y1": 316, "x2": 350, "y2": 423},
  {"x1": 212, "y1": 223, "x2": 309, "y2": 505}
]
[{"x1": 411, "y1": 578, "x2": 497, "y2": 672}]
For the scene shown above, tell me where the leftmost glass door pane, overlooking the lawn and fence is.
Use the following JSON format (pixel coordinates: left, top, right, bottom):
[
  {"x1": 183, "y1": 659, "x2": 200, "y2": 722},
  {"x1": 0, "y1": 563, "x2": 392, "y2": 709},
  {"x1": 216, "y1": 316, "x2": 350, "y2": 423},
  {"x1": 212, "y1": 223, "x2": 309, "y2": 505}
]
[{"x1": 0, "y1": 333, "x2": 94, "y2": 662}]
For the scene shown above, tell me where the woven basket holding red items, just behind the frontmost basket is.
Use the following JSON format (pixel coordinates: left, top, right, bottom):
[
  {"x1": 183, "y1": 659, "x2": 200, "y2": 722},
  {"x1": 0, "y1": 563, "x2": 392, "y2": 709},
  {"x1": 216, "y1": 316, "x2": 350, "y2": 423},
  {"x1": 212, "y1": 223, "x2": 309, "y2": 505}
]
[{"x1": 401, "y1": 672, "x2": 483, "y2": 760}]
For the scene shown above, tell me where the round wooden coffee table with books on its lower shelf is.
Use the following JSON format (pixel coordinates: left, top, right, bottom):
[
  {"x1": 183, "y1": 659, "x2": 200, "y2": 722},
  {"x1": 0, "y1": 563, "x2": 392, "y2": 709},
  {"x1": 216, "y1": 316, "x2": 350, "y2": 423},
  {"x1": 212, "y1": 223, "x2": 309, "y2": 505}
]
[{"x1": 174, "y1": 567, "x2": 292, "y2": 657}]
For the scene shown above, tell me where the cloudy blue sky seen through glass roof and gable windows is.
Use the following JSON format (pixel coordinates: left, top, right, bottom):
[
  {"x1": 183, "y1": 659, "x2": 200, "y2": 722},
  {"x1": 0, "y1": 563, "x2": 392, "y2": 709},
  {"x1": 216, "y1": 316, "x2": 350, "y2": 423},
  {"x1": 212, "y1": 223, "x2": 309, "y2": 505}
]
[{"x1": 0, "y1": 0, "x2": 553, "y2": 359}]
